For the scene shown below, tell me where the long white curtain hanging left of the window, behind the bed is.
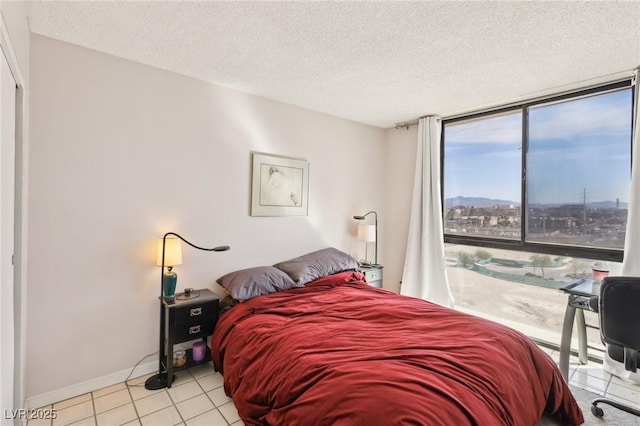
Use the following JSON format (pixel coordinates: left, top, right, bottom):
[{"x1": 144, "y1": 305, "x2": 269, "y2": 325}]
[{"x1": 400, "y1": 117, "x2": 453, "y2": 307}]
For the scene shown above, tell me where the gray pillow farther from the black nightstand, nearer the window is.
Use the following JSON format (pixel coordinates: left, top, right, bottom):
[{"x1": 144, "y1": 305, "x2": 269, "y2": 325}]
[{"x1": 273, "y1": 247, "x2": 358, "y2": 285}]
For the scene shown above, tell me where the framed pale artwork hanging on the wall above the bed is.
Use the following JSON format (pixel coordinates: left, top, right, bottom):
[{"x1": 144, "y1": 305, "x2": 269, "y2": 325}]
[{"x1": 251, "y1": 152, "x2": 309, "y2": 216}]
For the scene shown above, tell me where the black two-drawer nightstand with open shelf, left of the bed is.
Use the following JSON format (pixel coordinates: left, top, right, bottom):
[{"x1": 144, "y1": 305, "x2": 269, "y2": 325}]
[{"x1": 144, "y1": 289, "x2": 219, "y2": 390}]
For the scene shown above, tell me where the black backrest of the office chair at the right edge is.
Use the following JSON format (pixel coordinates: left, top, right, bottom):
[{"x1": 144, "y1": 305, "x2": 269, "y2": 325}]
[{"x1": 598, "y1": 277, "x2": 640, "y2": 371}]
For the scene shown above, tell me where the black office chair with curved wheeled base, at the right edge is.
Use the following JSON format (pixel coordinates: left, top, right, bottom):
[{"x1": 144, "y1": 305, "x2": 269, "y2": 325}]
[{"x1": 590, "y1": 277, "x2": 640, "y2": 417}]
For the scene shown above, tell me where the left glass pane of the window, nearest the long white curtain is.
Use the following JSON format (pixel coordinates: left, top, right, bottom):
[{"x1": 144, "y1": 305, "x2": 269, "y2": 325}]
[{"x1": 443, "y1": 110, "x2": 522, "y2": 240}]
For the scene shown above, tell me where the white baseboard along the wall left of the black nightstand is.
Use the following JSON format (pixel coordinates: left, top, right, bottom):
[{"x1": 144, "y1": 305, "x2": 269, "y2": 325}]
[{"x1": 25, "y1": 361, "x2": 158, "y2": 410}]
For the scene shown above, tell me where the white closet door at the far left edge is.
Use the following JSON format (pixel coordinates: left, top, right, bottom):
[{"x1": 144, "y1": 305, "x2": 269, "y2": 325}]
[{"x1": 0, "y1": 49, "x2": 20, "y2": 425}]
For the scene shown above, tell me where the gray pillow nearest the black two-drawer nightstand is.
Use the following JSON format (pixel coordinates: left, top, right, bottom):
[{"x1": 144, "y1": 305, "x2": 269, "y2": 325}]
[{"x1": 216, "y1": 266, "x2": 301, "y2": 300}]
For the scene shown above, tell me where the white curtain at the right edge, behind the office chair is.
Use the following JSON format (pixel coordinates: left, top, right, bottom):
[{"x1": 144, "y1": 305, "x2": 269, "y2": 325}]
[{"x1": 604, "y1": 68, "x2": 640, "y2": 384}]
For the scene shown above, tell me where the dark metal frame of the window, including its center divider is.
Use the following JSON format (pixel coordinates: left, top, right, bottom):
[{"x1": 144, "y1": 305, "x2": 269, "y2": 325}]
[{"x1": 440, "y1": 77, "x2": 637, "y2": 262}]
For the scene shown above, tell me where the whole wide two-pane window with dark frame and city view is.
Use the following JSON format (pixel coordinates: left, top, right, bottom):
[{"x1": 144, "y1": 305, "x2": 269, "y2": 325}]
[{"x1": 442, "y1": 80, "x2": 633, "y2": 261}]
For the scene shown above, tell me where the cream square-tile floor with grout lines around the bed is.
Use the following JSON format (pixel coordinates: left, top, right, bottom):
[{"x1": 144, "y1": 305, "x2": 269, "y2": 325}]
[{"x1": 28, "y1": 347, "x2": 640, "y2": 426}]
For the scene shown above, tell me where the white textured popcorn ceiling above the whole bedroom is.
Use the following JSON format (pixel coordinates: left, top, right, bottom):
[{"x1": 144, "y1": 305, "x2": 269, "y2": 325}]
[{"x1": 29, "y1": 0, "x2": 640, "y2": 128}]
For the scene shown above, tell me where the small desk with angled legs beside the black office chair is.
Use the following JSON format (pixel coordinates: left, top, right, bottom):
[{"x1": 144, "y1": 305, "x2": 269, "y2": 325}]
[{"x1": 559, "y1": 279, "x2": 600, "y2": 380}]
